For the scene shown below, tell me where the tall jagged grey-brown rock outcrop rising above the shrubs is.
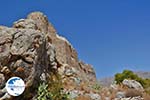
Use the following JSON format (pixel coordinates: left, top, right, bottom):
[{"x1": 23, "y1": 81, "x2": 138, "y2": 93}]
[{"x1": 0, "y1": 12, "x2": 97, "y2": 100}]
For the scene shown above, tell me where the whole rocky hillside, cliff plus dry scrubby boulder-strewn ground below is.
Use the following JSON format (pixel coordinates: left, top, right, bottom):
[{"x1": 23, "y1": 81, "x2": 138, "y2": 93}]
[{"x1": 0, "y1": 12, "x2": 150, "y2": 100}]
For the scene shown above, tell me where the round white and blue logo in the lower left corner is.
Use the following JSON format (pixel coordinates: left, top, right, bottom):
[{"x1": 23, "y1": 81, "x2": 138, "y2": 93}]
[{"x1": 6, "y1": 77, "x2": 25, "y2": 96}]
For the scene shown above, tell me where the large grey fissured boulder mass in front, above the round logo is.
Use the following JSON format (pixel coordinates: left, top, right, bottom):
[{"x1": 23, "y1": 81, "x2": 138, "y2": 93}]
[{"x1": 0, "y1": 28, "x2": 57, "y2": 99}]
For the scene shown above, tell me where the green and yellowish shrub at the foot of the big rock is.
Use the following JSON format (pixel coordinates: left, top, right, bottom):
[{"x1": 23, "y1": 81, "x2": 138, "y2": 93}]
[{"x1": 37, "y1": 70, "x2": 70, "y2": 100}]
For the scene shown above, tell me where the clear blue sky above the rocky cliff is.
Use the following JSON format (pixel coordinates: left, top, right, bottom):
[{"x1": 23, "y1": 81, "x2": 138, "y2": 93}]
[{"x1": 0, "y1": 0, "x2": 150, "y2": 78}]
